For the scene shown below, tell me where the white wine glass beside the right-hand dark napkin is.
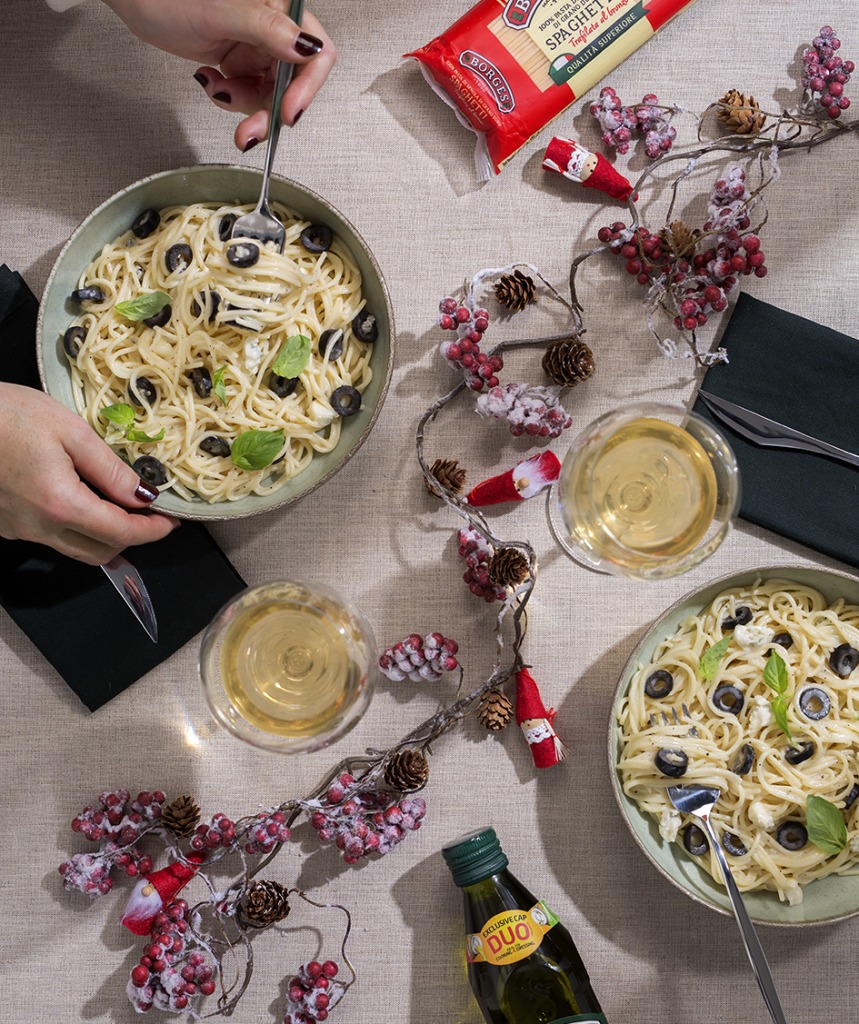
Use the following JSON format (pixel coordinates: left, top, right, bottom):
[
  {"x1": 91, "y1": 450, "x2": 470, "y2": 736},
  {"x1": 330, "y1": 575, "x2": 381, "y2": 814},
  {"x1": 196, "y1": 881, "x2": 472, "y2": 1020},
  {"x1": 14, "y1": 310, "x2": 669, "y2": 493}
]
[{"x1": 549, "y1": 402, "x2": 740, "y2": 580}]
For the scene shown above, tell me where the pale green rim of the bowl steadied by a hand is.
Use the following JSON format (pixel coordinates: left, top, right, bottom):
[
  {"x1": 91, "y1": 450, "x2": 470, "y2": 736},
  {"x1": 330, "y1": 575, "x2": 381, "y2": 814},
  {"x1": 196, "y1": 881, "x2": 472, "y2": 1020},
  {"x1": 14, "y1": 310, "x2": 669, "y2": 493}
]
[{"x1": 36, "y1": 163, "x2": 396, "y2": 523}]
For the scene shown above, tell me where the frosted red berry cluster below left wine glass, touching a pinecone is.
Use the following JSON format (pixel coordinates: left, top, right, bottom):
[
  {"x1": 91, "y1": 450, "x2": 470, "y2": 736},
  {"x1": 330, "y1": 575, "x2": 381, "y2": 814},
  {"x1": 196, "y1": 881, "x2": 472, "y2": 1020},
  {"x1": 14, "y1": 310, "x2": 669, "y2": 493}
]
[{"x1": 307, "y1": 772, "x2": 427, "y2": 864}]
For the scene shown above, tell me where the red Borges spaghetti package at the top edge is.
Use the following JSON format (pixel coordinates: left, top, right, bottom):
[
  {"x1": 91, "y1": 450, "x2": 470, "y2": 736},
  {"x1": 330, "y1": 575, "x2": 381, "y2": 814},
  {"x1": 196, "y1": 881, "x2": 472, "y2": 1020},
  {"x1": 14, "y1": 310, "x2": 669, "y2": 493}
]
[{"x1": 405, "y1": 0, "x2": 694, "y2": 179}]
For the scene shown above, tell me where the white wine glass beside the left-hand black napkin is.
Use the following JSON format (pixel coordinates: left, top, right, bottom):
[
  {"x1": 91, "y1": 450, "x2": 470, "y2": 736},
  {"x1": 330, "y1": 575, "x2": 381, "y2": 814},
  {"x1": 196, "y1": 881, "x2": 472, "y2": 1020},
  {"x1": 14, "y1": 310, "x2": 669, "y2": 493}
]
[{"x1": 200, "y1": 580, "x2": 376, "y2": 754}]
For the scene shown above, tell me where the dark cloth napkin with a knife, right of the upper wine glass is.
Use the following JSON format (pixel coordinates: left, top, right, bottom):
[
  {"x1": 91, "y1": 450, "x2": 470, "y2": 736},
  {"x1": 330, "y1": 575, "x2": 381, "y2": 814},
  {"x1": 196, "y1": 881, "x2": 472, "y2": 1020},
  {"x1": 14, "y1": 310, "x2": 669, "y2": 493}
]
[{"x1": 694, "y1": 293, "x2": 859, "y2": 566}]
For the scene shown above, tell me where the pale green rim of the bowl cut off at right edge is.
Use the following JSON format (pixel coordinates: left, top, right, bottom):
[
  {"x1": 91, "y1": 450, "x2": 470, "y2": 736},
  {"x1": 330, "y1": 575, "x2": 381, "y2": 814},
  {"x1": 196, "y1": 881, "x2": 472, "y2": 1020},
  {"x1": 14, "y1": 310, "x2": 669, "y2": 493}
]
[{"x1": 607, "y1": 563, "x2": 859, "y2": 928}]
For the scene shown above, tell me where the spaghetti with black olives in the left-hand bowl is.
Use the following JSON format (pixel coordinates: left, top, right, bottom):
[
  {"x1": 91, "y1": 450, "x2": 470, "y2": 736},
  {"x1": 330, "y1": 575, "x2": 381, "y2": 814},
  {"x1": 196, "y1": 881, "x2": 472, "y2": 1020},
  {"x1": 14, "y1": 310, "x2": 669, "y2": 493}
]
[{"x1": 63, "y1": 203, "x2": 373, "y2": 502}]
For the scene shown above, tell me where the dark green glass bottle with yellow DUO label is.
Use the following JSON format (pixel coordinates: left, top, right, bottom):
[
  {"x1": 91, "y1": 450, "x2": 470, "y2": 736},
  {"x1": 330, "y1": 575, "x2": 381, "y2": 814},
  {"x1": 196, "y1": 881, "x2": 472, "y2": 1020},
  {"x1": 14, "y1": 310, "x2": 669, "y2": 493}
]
[{"x1": 441, "y1": 828, "x2": 606, "y2": 1024}]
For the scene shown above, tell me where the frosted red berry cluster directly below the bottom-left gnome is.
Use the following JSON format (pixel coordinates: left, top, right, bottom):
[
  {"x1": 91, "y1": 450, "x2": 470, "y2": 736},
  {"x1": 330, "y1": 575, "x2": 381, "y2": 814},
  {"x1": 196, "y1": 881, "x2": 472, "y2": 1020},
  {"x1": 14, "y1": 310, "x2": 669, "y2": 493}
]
[{"x1": 126, "y1": 899, "x2": 215, "y2": 1013}]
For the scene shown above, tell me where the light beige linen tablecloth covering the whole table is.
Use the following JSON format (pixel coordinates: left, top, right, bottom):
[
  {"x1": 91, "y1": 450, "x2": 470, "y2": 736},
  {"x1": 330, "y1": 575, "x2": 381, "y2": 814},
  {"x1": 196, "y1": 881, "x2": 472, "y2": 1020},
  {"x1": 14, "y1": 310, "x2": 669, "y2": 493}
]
[{"x1": 0, "y1": 0, "x2": 859, "y2": 1024}]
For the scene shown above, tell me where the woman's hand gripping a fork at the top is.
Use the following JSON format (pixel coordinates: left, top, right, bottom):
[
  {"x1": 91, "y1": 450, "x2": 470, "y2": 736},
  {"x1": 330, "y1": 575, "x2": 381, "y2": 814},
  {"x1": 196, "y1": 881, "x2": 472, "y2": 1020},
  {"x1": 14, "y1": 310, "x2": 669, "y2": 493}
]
[{"x1": 104, "y1": 0, "x2": 337, "y2": 152}]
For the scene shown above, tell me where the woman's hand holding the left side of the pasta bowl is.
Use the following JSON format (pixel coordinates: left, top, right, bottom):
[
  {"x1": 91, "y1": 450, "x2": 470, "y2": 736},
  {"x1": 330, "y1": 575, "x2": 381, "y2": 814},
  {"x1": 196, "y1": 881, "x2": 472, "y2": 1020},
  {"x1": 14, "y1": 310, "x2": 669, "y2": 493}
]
[{"x1": 0, "y1": 384, "x2": 179, "y2": 565}]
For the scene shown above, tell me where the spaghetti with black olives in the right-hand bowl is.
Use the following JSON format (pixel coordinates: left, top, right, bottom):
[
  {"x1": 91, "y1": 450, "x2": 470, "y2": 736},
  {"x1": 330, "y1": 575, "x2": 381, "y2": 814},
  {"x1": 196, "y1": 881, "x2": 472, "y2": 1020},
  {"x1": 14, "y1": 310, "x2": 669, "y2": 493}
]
[{"x1": 617, "y1": 580, "x2": 859, "y2": 904}]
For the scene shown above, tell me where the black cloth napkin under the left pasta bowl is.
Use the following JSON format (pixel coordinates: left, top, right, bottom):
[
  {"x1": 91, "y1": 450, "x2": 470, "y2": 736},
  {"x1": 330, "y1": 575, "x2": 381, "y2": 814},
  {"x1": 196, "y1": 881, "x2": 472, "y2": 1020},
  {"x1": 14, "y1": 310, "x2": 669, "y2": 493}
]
[{"x1": 0, "y1": 265, "x2": 245, "y2": 711}]
